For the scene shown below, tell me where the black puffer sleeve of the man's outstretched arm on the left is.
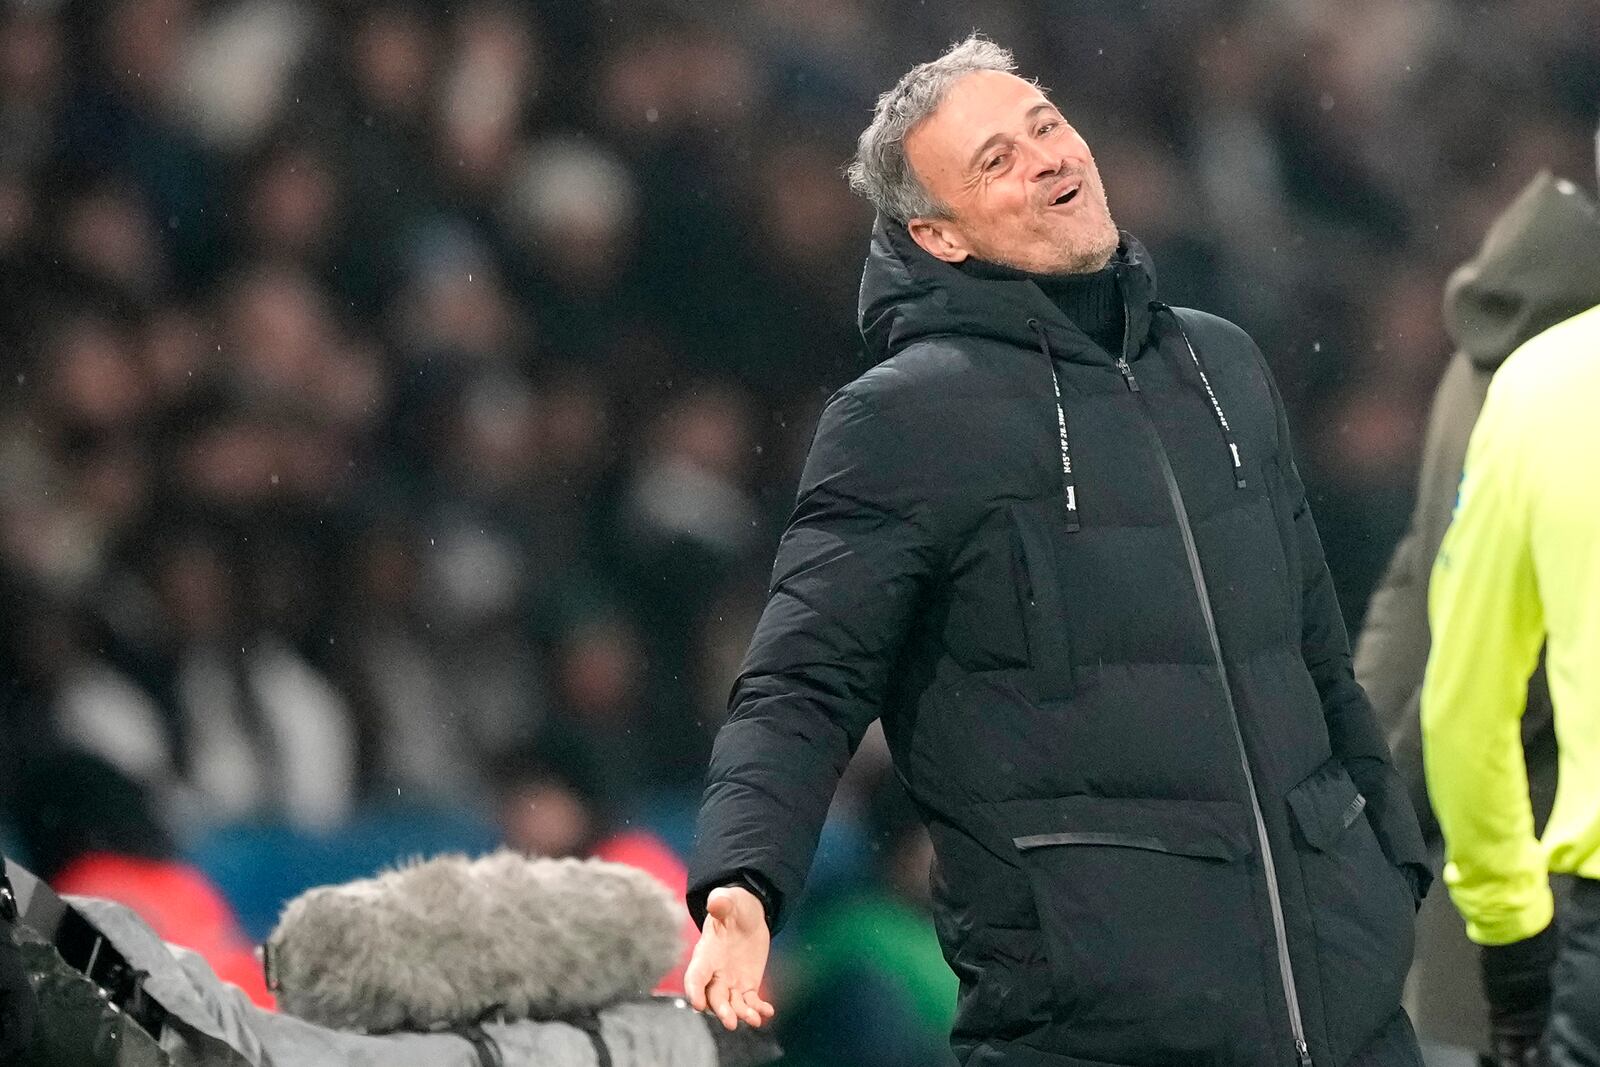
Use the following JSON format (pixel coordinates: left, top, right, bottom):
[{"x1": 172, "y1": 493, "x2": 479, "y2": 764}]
[{"x1": 688, "y1": 390, "x2": 934, "y2": 928}]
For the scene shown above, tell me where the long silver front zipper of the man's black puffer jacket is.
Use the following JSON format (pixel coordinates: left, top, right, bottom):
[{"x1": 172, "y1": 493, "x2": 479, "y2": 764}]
[{"x1": 1117, "y1": 304, "x2": 1312, "y2": 1067}]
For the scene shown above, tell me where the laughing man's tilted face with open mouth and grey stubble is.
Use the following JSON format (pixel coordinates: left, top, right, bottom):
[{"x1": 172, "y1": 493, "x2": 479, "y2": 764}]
[{"x1": 906, "y1": 70, "x2": 1117, "y2": 274}]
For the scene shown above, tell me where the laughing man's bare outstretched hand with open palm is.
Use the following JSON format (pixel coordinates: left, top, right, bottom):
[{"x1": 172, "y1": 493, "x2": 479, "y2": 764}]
[{"x1": 683, "y1": 886, "x2": 774, "y2": 1030}]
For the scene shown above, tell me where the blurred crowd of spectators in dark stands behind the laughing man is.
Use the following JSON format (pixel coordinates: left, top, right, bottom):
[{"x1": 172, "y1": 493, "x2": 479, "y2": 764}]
[{"x1": 0, "y1": 0, "x2": 1600, "y2": 1064}]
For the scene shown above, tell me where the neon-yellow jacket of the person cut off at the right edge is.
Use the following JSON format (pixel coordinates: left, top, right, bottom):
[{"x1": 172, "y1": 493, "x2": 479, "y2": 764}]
[{"x1": 1422, "y1": 299, "x2": 1600, "y2": 945}]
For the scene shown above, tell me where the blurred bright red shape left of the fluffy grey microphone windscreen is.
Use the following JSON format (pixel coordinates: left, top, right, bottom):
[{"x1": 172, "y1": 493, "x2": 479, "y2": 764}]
[{"x1": 54, "y1": 853, "x2": 276, "y2": 1009}]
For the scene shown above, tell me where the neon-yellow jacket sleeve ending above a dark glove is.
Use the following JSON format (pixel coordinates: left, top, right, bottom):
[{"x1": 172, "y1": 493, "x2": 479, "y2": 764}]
[{"x1": 1422, "y1": 373, "x2": 1554, "y2": 945}]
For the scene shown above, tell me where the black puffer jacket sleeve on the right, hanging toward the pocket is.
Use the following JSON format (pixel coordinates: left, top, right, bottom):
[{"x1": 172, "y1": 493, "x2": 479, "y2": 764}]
[{"x1": 1262, "y1": 360, "x2": 1434, "y2": 897}]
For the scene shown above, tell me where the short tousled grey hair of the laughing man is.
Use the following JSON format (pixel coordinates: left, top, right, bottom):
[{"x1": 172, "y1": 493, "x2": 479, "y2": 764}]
[{"x1": 845, "y1": 34, "x2": 1016, "y2": 222}]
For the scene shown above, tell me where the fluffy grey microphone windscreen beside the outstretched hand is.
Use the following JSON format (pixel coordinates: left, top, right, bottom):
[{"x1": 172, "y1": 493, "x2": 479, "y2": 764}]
[{"x1": 267, "y1": 851, "x2": 682, "y2": 1033}]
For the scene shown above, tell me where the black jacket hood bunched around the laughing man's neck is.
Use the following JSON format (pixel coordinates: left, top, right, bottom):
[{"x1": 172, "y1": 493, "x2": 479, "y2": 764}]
[{"x1": 859, "y1": 214, "x2": 1155, "y2": 363}]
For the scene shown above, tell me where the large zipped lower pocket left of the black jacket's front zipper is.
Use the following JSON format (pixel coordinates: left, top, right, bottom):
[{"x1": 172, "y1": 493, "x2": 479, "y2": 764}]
[{"x1": 1003, "y1": 797, "x2": 1269, "y2": 1064}]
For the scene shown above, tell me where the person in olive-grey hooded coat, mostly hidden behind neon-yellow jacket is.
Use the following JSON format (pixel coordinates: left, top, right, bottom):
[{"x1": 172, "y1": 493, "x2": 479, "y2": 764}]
[{"x1": 1355, "y1": 154, "x2": 1600, "y2": 1062}]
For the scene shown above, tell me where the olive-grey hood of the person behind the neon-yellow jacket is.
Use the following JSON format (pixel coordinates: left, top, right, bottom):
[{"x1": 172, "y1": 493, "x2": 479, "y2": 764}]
[{"x1": 1445, "y1": 171, "x2": 1600, "y2": 370}]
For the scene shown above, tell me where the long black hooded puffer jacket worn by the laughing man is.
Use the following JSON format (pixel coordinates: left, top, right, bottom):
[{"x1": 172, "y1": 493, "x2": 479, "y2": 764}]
[{"x1": 691, "y1": 222, "x2": 1426, "y2": 1067}]
